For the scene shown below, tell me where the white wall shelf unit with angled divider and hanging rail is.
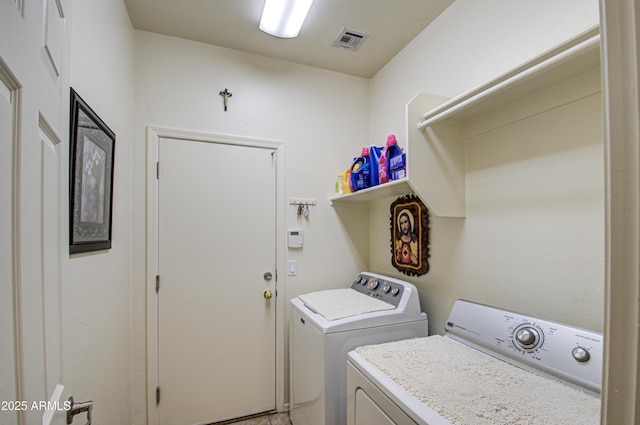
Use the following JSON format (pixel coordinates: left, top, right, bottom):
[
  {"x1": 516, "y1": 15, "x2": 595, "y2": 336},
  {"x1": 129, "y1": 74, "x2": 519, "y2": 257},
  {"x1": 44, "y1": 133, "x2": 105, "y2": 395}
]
[{"x1": 331, "y1": 27, "x2": 601, "y2": 217}]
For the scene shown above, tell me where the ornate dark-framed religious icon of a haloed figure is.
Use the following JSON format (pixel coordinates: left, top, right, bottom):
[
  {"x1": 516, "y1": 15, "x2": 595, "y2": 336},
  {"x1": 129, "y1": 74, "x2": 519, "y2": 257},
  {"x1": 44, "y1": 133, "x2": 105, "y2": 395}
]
[{"x1": 391, "y1": 195, "x2": 429, "y2": 276}]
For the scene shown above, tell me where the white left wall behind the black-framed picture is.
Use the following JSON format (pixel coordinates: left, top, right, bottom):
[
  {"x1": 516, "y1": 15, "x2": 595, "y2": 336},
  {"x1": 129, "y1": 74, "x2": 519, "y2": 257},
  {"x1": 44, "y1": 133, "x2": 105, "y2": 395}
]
[{"x1": 63, "y1": 0, "x2": 133, "y2": 424}]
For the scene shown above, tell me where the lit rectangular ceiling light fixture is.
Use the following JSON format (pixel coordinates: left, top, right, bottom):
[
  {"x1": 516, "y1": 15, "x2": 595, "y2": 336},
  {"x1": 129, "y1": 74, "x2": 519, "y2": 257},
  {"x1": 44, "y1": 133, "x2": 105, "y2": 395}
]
[{"x1": 260, "y1": 0, "x2": 313, "y2": 38}]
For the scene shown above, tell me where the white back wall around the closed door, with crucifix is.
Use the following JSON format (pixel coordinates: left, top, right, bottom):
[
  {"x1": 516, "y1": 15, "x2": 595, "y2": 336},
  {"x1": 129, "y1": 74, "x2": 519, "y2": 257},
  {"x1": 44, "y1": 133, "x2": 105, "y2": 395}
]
[{"x1": 132, "y1": 31, "x2": 369, "y2": 423}]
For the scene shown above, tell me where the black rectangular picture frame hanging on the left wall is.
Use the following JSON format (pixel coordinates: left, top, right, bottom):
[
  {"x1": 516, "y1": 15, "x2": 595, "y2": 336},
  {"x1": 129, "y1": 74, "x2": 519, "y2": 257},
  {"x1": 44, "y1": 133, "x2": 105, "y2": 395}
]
[{"x1": 69, "y1": 89, "x2": 116, "y2": 254}]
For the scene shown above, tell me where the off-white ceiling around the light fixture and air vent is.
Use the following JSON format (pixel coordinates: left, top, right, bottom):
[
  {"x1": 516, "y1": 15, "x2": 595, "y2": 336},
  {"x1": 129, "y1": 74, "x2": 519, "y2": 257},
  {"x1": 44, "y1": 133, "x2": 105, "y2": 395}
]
[{"x1": 124, "y1": 0, "x2": 453, "y2": 78}]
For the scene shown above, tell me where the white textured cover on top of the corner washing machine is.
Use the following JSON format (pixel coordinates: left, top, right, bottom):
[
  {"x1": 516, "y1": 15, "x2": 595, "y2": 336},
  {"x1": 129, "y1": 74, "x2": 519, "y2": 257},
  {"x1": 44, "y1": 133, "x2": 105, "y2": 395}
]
[{"x1": 299, "y1": 288, "x2": 396, "y2": 320}]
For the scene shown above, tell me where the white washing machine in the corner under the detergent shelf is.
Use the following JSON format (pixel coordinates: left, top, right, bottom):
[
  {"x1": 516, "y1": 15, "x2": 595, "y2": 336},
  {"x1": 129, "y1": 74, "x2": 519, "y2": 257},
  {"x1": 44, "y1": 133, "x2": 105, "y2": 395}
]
[{"x1": 290, "y1": 272, "x2": 428, "y2": 425}]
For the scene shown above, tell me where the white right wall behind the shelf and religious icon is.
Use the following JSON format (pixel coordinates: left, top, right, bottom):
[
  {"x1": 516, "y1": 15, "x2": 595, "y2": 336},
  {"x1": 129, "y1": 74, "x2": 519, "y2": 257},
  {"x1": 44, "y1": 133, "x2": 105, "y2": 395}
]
[{"x1": 370, "y1": 0, "x2": 604, "y2": 333}]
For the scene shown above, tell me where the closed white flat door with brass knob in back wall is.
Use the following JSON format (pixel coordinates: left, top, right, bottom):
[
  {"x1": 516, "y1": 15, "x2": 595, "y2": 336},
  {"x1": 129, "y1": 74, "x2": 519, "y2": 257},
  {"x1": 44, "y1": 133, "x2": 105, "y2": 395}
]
[{"x1": 158, "y1": 138, "x2": 276, "y2": 425}]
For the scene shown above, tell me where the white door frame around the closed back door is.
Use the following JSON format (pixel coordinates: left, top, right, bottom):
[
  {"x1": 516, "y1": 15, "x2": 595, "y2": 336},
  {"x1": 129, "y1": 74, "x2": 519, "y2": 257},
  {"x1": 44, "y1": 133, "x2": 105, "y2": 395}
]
[{"x1": 146, "y1": 126, "x2": 286, "y2": 424}]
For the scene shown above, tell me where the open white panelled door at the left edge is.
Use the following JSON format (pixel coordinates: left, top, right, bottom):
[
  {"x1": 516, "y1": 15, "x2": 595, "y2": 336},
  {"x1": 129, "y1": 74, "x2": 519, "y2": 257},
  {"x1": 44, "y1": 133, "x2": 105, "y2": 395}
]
[{"x1": 0, "y1": 0, "x2": 70, "y2": 425}]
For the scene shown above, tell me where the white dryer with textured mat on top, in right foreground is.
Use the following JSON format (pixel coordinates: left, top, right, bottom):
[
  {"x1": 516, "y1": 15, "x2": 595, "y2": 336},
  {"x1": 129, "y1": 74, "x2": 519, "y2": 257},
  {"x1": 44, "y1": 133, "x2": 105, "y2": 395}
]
[{"x1": 347, "y1": 300, "x2": 604, "y2": 425}]
